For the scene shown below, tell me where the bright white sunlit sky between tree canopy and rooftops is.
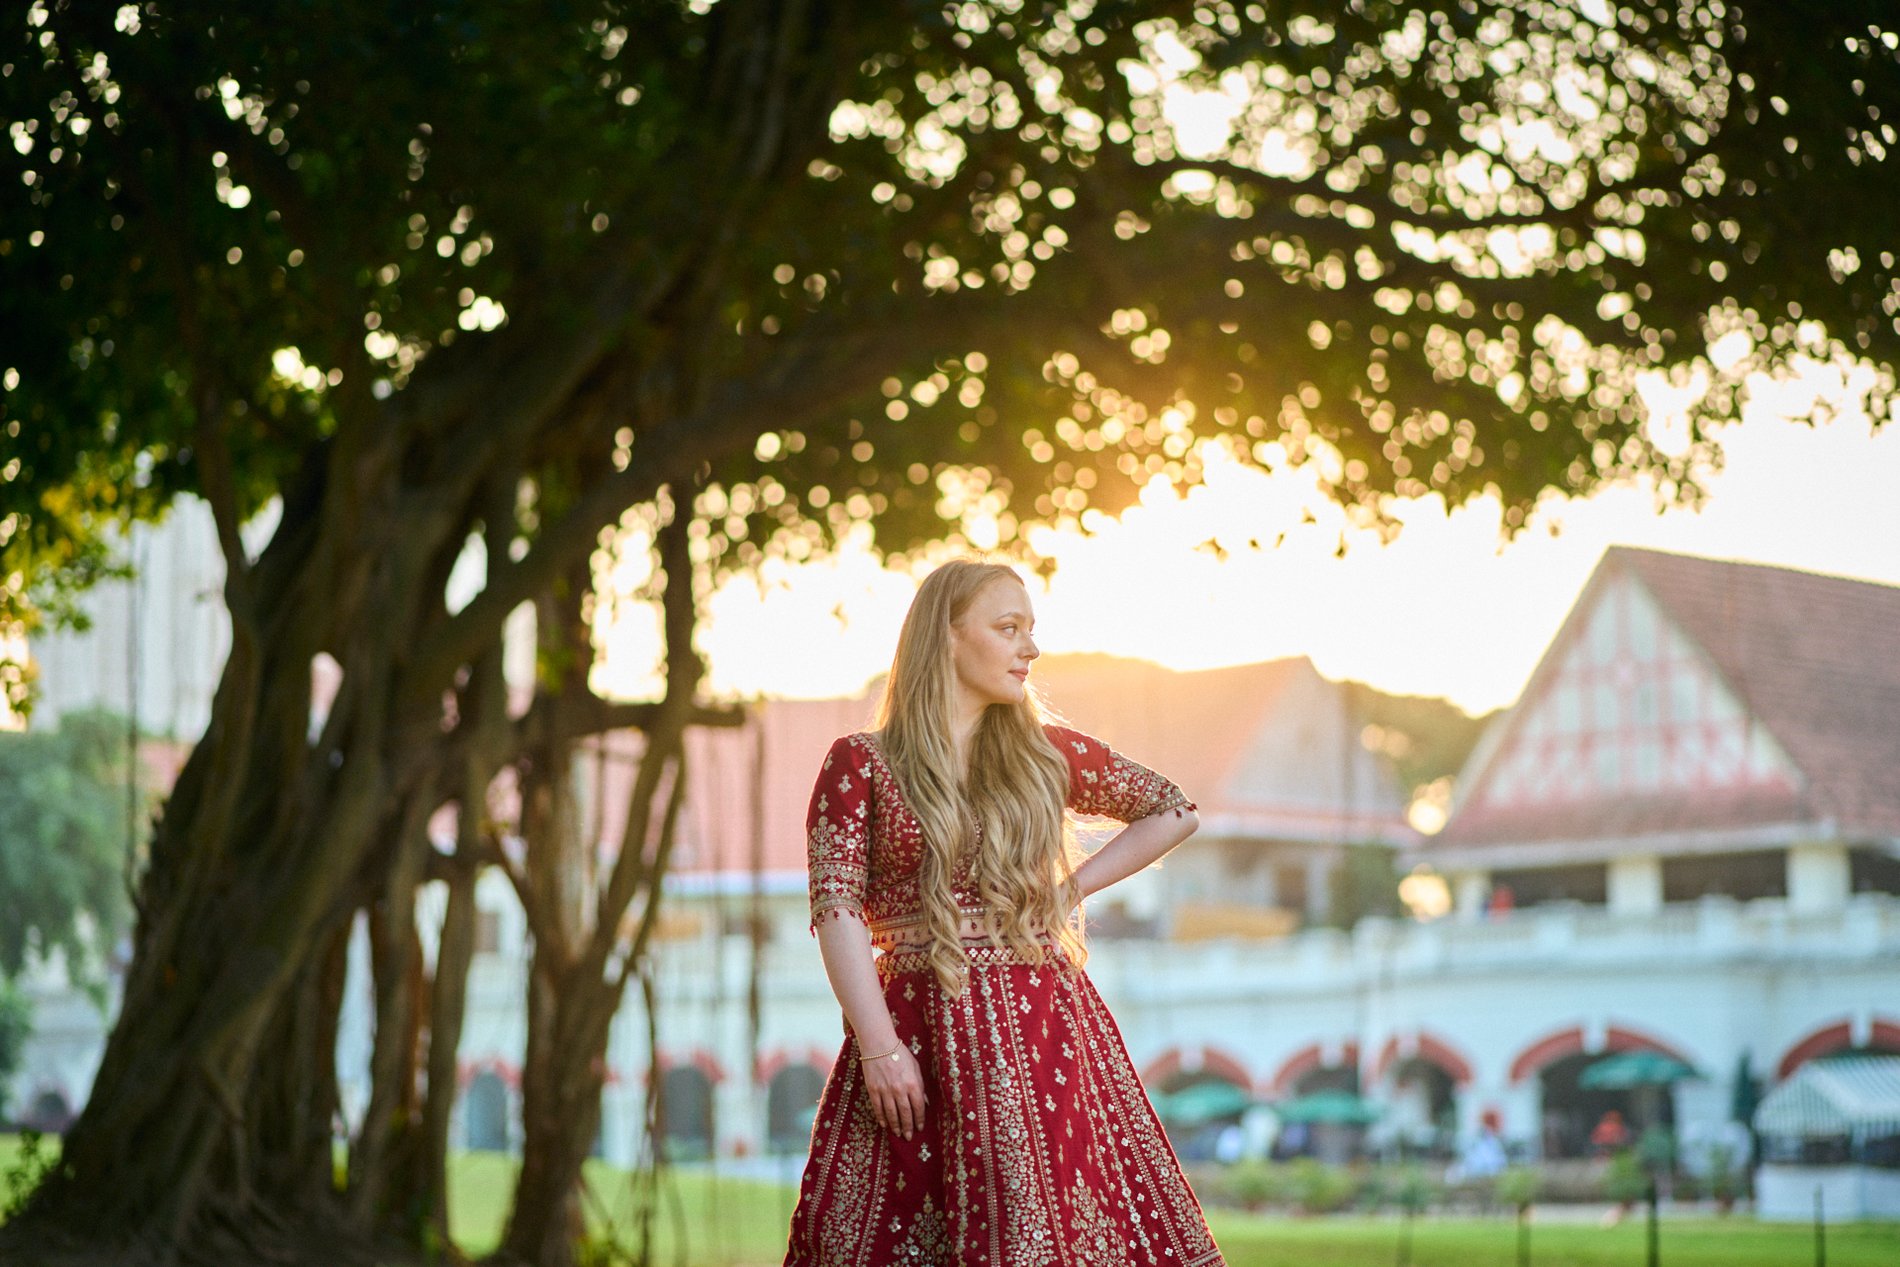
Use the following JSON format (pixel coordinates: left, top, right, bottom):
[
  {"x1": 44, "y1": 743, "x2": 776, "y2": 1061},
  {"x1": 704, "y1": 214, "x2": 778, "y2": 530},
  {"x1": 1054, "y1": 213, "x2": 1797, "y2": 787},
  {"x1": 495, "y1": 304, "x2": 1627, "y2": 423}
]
[{"x1": 597, "y1": 368, "x2": 1900, "y2": 712}]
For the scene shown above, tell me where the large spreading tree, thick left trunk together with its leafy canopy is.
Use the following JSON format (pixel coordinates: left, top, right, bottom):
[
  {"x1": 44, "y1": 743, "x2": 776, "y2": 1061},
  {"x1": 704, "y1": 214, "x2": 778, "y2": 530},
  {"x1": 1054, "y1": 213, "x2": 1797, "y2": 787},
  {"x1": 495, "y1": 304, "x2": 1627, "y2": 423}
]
[{"x1": 0, "y1": 0, "x2": 1900, "y2": 1259}]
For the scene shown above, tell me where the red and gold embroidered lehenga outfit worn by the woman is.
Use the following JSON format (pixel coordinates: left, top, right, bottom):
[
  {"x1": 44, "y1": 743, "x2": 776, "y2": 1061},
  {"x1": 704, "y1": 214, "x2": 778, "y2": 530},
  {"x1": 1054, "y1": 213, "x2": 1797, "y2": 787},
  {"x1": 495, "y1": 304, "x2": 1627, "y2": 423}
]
[{"x1": 785, "y1": 726, "x2": 1226, "y2": 1267}]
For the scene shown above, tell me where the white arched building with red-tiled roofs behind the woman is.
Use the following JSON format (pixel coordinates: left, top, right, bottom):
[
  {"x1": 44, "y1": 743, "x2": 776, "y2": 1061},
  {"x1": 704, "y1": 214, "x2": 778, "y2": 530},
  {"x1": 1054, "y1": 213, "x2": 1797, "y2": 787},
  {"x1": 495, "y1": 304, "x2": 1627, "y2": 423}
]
[{"x1": 513, "y1": 549, "x2": 1900, "y2": 1157}]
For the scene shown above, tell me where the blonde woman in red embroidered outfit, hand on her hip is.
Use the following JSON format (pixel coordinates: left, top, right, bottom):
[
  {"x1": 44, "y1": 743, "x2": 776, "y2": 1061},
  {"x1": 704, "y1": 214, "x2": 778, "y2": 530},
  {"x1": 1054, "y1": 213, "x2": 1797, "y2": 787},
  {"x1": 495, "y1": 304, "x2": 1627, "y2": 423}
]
[{"x1": 785, "y1": 562, "x2": 1224, "y2": 1267}]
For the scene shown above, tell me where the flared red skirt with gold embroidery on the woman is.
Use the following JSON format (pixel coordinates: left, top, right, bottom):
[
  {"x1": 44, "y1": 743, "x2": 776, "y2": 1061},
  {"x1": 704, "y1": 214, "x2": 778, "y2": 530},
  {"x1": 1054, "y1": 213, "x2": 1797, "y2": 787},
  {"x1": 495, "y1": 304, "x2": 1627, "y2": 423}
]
[{"x1": 785, "y1": 946, "x2": 1226, "y2": 1267}]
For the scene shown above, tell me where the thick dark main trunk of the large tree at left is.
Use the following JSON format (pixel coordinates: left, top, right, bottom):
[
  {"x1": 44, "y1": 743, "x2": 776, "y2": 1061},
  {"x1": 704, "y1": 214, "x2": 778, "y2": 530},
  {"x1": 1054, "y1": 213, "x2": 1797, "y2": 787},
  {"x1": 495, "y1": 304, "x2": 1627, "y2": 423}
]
[{"x1": 0, "y1": 446, "x2": 505, "y2": 1261}]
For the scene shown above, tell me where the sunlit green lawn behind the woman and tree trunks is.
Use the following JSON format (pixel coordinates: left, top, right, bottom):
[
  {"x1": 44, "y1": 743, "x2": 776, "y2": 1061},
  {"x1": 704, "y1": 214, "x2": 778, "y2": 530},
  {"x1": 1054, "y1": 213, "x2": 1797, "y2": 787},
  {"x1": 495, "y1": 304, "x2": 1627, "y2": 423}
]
[{"x1": 0, "y1": 1136, "x2": 1900, "y2": 1267}]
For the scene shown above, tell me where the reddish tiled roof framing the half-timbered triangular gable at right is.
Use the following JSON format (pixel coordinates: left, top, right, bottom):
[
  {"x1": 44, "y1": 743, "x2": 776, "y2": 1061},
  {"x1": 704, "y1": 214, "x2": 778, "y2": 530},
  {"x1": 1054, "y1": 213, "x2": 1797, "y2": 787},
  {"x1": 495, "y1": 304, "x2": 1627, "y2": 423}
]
[{"x1": 1429, "y1": 545, "x2": 1900, "y2": 860}]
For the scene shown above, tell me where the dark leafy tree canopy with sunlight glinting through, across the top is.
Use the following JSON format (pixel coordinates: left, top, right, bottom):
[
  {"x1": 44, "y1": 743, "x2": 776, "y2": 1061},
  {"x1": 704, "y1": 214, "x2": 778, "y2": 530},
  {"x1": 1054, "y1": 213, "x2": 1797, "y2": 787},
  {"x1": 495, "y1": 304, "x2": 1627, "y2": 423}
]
[{"x1": 0, "y1": 0, "x2": 1900, "y2": 645}]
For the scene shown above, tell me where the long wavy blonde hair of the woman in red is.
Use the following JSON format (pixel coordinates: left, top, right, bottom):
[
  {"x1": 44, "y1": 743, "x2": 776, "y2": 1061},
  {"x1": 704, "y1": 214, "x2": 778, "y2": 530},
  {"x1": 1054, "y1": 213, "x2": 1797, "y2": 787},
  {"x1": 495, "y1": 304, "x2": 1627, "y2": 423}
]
[{"x1": 878, "y1": 560, "x2": 1089, "y2": 995}]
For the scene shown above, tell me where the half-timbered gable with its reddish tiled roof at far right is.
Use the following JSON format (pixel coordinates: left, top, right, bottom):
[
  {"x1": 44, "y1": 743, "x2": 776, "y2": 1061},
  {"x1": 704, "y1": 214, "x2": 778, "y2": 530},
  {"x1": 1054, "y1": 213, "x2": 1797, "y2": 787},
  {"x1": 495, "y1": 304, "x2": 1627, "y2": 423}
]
[{"x1": 1421, "y1": 547, "x2": 1900, "y2": 908}]
